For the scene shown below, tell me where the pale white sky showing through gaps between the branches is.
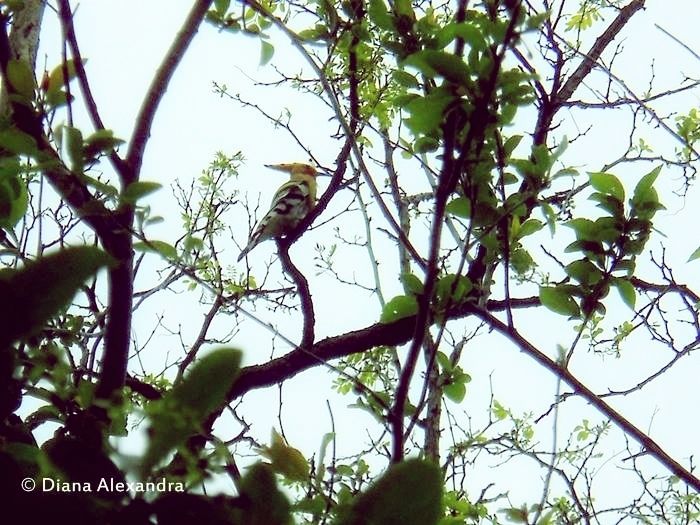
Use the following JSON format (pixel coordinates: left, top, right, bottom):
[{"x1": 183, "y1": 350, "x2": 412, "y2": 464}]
[{"x1": 31, "y1": 0, "x2": 700, "y2": 510}]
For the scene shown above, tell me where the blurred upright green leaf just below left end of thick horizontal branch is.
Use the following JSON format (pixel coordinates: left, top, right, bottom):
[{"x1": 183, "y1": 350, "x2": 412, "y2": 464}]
[{"x1": 141, "y1": 348, "x2": 241, "y2": 474}]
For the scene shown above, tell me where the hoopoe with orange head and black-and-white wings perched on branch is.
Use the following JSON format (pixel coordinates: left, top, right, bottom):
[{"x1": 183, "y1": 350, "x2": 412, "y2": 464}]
[{"x1": 238, "y1": 162, "x2": 316, "y2": 261}]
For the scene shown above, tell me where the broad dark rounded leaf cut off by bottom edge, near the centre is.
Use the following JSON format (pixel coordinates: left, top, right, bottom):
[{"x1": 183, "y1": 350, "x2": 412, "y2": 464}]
[{"x1": 337, "y1": 459, "x2": 443, "y2": 525}]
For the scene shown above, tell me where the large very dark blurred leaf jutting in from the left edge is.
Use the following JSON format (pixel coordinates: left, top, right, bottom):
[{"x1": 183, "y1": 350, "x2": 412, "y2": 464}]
[{"x1": 0, "y1": 246, "x2": 112, "y2": 348}]
